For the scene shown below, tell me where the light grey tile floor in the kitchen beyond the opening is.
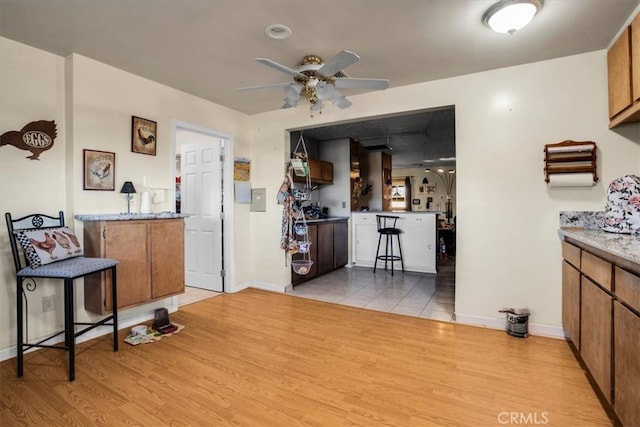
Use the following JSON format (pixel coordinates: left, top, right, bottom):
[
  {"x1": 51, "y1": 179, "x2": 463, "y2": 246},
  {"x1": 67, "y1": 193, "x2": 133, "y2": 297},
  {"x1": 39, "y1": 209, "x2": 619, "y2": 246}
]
[{"x1": 290, "y1": 258, "x2": 455, "y2": 322}]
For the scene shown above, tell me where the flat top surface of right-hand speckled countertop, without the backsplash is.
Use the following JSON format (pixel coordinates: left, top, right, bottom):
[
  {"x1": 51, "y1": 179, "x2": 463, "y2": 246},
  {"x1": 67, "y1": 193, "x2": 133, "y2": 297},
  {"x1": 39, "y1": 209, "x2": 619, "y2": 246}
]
[{"x1": 558, "y1": 227, "x2": 640, "y2": 264}]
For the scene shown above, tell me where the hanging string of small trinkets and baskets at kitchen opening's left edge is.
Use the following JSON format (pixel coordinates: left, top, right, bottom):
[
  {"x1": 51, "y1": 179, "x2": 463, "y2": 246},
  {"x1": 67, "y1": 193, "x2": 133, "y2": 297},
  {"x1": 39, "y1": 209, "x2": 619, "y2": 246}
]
[{"x1": 278, "y1": 134, "x2": 313, "y2": 275}]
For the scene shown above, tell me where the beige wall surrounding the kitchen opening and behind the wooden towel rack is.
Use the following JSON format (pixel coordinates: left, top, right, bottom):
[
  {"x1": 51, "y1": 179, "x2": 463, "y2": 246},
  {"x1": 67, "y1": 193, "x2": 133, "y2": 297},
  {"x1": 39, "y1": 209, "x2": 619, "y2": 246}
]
[{"x1": 245, "y1": 51, "x2": 640, "y2": 333}]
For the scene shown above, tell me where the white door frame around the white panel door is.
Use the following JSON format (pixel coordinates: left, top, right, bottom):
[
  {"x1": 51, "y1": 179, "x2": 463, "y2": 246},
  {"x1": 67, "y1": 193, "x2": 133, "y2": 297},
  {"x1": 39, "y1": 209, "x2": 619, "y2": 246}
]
[{"x1": 171, "y1": 120, "x2": 235, "y2": 293}]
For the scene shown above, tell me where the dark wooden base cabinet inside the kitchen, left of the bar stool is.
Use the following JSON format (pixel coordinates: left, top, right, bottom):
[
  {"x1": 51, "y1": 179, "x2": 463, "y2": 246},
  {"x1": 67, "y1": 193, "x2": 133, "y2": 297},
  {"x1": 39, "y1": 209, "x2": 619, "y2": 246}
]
[{"x1": 291, "y1": 220, "x2": 349, "y2": 285}]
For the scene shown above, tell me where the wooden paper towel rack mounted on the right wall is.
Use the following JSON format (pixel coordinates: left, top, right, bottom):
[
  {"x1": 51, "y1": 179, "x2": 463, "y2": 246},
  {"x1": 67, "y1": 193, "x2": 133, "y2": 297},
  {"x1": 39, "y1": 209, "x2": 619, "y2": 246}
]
[{"x1": 544, "y1": 141, "x2": 598, "y2": 183}]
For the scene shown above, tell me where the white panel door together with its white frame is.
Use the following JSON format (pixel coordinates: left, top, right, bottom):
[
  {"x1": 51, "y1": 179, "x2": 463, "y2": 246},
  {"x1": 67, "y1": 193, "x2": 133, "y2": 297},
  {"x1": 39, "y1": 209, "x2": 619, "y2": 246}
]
[{"x1": 173, "y1": 121, "x2": 235, "y2": 292}]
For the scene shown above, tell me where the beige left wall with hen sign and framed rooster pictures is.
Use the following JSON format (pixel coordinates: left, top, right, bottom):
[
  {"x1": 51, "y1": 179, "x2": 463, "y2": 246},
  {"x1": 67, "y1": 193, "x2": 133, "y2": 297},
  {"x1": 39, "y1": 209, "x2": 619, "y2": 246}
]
[{"x1": 0, "y1": 38, "x2": 250, "y2": 353}]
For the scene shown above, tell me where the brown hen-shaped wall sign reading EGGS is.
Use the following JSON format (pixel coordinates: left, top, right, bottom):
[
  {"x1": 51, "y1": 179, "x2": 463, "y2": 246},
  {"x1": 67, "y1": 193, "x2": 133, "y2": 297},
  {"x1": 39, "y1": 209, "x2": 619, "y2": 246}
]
[{"x1": 0, "y1": 120, "x2": 58, "y2": 160}]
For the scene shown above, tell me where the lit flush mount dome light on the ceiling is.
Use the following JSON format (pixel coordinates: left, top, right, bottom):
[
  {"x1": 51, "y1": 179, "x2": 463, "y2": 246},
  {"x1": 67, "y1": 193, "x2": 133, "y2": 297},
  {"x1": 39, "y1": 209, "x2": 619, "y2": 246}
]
[{"x1": 482, "y1": 0, "x2": 543, "y2": 34}]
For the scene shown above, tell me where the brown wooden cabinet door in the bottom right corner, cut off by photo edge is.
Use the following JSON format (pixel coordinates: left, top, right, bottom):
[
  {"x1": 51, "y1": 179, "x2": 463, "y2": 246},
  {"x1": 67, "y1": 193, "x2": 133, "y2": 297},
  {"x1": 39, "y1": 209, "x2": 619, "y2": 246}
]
[{"x1": 613, "y1": 301, "x2": 640, "y2": 426}]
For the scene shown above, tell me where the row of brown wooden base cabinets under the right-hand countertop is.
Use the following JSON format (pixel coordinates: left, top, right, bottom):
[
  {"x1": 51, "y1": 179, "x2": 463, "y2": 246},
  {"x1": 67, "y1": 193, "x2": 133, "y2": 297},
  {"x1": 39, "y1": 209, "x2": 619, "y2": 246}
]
[{"x1": 562, "y1": 240, "x2": 640, "y2": 426}]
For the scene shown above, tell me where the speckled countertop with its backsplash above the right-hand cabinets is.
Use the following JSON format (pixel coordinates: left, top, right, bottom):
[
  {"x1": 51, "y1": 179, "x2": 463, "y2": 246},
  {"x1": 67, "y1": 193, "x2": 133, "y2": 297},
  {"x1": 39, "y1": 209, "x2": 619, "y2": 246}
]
[{"x1": 558, "y1": 212, "x2": 640, "y2": 264}]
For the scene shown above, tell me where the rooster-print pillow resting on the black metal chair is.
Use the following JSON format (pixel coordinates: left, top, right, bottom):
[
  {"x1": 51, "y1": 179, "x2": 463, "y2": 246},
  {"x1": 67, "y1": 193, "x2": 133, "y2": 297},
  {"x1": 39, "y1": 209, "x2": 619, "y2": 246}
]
[{"x1": 16, "y1": 227, "x2": 82, "y2": 268}]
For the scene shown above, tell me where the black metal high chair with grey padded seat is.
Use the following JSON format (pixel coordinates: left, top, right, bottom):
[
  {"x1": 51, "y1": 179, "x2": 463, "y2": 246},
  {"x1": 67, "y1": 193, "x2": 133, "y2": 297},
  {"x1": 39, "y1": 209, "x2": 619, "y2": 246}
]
[{"x1": 5, "y1": 211, "x2": 119, "y2": 381}]
